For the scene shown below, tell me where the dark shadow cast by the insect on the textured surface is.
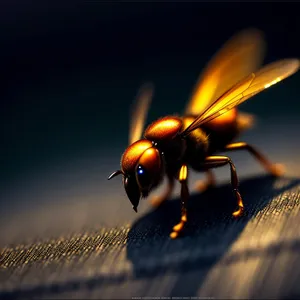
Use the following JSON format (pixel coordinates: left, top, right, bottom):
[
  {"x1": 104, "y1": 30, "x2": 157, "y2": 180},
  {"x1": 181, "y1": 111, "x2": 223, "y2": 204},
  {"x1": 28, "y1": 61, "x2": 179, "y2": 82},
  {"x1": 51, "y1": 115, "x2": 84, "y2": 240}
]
[{"x1": 127, "y1": 175, "x2": 300, "y2": 297}]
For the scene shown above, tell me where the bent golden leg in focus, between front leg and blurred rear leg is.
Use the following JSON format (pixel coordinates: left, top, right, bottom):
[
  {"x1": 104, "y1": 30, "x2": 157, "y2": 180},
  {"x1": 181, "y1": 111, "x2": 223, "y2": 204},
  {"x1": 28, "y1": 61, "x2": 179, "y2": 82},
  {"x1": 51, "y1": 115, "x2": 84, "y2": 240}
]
[{"x1": 204, "y1": 156, "x2": 244, "y2": 217}]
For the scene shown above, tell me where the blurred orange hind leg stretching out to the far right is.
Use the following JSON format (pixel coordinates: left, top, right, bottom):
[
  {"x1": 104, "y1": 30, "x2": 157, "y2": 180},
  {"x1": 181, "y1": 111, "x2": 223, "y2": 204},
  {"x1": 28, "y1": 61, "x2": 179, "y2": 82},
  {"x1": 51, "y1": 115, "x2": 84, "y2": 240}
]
[{"x1": 225, "y1": 142, "x2": 284, "y2": 176}]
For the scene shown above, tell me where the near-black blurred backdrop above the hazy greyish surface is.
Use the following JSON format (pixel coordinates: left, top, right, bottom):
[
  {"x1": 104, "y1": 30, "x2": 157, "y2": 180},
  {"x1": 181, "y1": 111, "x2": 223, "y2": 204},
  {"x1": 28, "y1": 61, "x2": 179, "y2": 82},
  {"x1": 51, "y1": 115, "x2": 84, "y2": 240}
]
[{"x1": 0, "y1": 0, "x2": 300, "y2": 186}]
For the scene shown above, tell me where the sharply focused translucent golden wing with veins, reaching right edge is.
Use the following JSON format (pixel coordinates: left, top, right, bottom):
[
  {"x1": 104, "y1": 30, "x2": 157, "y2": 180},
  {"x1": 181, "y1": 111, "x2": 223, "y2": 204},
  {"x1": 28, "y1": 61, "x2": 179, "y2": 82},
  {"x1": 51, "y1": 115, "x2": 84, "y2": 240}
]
[{"x1": 181, "y1": 59, "x2": 300, "y2": 135}]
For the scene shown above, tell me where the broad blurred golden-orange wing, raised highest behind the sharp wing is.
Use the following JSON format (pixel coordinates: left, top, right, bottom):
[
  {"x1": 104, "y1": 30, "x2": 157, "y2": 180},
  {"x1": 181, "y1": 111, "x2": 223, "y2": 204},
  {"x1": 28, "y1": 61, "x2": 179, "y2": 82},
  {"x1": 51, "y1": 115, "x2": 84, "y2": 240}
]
[{"x1": 185, "y1": 29, "x2": 265, "y2": 116}]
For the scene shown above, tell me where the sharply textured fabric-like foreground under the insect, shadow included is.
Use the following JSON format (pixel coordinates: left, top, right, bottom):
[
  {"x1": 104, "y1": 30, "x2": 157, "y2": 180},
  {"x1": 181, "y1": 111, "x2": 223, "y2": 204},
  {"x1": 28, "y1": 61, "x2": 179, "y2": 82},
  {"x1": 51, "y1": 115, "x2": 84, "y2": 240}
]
[{"x1": 0, "y1": 176, "x2": 300, "y2": 299}]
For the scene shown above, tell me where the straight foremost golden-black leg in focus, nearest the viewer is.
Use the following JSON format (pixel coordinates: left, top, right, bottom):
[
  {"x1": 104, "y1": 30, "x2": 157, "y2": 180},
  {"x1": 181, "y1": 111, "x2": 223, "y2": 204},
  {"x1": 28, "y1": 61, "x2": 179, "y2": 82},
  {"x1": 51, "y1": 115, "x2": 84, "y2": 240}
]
[{"x1": 170, "y1": 165, "x2": 189, "y2": 239}]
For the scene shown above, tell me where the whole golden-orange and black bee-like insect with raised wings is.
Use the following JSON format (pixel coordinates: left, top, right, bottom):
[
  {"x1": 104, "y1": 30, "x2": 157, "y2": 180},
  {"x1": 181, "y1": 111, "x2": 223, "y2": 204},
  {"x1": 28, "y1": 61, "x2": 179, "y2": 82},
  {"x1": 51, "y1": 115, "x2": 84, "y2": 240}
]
[{"x1": 108, "y1": 29, "x2": 299, "y2": 238}]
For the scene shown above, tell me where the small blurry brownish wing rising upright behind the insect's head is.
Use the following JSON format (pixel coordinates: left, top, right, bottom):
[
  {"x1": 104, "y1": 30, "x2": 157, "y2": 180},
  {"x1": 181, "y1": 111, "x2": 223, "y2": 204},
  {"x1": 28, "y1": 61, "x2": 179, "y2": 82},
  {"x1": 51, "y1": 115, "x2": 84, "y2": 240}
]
[{"x1": 129, "y1": 83, "x2": 154, "y2": 145}]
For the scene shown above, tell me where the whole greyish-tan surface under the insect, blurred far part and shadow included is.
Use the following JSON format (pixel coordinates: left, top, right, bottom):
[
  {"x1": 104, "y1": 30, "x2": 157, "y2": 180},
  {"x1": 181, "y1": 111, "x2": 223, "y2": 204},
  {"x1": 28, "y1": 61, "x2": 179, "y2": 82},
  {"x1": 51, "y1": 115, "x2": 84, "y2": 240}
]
[{"x1": 0, "y1": 117, "x2": 300, "y2": 299}]
